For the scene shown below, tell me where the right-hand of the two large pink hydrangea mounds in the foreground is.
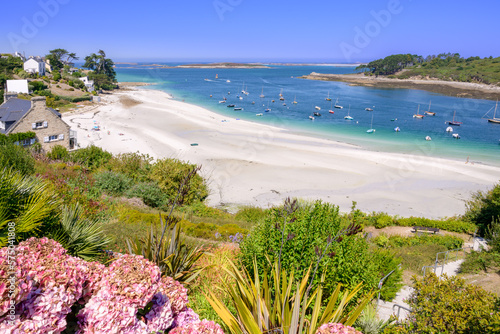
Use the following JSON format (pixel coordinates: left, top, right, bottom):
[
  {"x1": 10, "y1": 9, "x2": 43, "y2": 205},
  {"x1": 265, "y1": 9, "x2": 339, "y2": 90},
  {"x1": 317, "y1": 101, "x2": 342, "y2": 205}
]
[{"x1": 78, "y1": 254, "x2": 188, "y2": 334}]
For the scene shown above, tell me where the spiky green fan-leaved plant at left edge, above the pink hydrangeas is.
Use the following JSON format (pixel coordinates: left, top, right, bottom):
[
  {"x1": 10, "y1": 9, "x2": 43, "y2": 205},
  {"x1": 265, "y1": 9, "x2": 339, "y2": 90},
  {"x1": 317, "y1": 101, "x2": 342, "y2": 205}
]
[{"x1": 0, "y1": 169, "x2": 59, "y2": 247}]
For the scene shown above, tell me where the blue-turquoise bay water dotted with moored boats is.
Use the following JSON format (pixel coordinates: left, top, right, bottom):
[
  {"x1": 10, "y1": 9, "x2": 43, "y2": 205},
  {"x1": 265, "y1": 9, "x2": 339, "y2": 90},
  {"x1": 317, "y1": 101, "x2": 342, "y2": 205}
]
[{"x1": 116, "y1": 64, "x2": 500, "y2": 166}]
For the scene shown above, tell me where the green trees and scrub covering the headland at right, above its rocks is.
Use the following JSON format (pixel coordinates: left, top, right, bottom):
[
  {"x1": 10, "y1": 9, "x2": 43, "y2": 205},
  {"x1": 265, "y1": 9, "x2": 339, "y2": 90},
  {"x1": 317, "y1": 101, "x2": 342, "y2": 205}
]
[{"x1": 357, "y1": 53, "x2": 500, "y2": 85}]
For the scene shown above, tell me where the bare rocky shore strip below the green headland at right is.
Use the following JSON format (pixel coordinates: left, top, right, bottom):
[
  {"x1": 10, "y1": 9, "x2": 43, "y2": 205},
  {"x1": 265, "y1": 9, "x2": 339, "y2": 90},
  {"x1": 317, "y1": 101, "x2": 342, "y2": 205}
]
[{"x1": 298, "y1": 72, "x2": 500, "y2": 100}]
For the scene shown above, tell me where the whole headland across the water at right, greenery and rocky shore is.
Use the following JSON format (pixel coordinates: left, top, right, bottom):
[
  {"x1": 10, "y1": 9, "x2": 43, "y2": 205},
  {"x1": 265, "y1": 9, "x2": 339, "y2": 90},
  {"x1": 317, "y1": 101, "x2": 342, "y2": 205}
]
[{"x1": 300, "y1": 53, "x2": 500, "y2": 100}]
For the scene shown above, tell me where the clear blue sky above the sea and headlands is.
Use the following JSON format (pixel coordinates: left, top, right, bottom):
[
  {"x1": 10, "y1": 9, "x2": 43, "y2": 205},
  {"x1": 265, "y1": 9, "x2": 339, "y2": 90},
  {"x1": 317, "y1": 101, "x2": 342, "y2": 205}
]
[{"x1": 0, "y1": 0, "x2": 500, "y2": 62}]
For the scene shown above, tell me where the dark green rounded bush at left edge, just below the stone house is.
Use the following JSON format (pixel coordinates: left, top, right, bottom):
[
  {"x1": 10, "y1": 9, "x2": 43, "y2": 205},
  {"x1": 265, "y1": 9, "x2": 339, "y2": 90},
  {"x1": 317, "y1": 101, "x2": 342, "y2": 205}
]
[{"x1": 0, "y1": 143, "x2": 35, "y2": 175}]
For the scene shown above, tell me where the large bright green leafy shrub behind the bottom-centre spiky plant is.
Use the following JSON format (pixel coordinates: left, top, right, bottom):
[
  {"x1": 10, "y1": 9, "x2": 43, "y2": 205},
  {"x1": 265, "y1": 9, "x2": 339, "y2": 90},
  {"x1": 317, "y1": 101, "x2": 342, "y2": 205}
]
[{"x1": 240, "y1": 201, "x2": 402, "y2": 296}]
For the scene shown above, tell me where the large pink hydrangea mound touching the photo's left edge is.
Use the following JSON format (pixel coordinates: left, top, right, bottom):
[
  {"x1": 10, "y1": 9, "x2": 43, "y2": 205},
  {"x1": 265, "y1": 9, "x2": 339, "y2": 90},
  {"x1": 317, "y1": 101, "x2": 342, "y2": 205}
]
[{"x1": 0, "y1": 238, "x2": 104, "y2": 333}]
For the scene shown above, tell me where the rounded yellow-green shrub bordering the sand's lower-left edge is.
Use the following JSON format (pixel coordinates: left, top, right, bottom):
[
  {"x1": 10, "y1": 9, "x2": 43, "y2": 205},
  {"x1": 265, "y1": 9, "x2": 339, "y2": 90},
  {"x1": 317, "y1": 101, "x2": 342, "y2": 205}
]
[{"x1": 150, "y1": 159, "x2": 208, "y2": 205}]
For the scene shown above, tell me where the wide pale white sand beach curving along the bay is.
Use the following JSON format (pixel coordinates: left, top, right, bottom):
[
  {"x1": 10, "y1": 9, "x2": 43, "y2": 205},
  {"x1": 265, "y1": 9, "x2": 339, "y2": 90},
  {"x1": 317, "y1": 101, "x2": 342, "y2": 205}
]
[{"x1": 63, "y1": 90, "x2": 500, "y2": 218}]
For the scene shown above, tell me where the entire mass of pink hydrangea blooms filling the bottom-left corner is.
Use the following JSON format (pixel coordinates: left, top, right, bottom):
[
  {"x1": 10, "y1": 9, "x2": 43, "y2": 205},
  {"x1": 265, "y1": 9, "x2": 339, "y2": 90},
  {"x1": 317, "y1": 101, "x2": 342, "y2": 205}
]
[{"x1": 0, "y1": 238, "x2": 223, "y2": 334}]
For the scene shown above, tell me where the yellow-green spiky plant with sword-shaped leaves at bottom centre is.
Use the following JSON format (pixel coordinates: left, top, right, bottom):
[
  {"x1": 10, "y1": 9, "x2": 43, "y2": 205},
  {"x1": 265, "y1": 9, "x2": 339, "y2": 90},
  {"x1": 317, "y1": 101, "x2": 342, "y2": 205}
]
[{"x1": 206, "y1": 261, "x2": 373, "y2": 334}]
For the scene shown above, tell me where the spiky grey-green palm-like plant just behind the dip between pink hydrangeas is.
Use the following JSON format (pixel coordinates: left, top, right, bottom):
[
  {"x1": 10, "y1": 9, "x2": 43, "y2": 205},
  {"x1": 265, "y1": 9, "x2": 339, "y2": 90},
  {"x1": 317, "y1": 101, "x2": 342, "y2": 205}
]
[{"x1": 49, "y1": 204, "x2": 111, "y2": 261}]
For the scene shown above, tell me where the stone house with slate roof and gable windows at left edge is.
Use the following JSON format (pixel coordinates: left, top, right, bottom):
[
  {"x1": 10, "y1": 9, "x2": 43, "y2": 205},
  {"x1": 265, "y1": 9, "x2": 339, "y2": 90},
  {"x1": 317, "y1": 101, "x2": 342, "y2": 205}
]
[{"x1": 0, "y1": 94, "x2": 77, "y2": 152}]
